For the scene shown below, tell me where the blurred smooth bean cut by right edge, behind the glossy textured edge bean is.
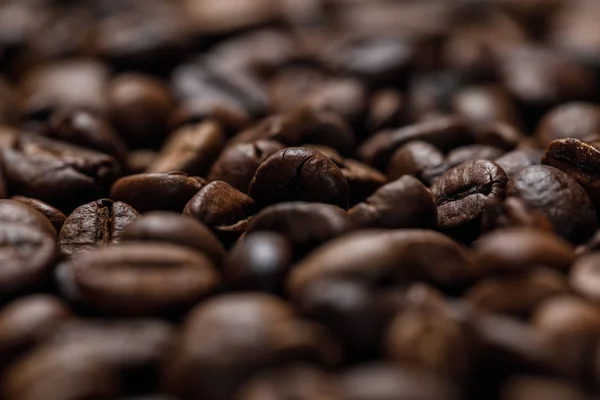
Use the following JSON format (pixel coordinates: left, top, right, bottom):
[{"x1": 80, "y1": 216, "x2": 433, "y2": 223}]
[{"x1": 536, "y1": 102, "x2": 600, "y2": 146}]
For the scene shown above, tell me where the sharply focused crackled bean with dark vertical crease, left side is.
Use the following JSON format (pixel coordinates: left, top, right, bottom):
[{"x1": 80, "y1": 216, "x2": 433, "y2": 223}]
[{"x1": 58, "y1": 199, "x2": 140, "y2": 257}]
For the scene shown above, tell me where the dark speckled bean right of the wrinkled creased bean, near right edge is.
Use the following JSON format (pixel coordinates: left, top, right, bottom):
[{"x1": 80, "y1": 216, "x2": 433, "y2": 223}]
[{"x1": 509, "y1": 165, "x2": 598, "y2": 243}]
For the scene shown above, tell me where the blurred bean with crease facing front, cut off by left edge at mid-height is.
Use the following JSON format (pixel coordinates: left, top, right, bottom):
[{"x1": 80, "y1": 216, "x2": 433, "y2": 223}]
[{"x1": 0, "y1": 223, "x2": 58, "y2": 298}]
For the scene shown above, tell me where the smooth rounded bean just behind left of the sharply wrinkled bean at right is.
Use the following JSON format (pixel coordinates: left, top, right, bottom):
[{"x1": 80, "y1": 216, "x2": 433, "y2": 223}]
[{"x1": 387, "y1": 140, "x2": 448, "y2": 186}]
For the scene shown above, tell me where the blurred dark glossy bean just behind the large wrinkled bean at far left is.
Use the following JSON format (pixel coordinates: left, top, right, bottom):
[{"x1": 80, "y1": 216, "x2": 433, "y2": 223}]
[{"x1": 48, "y1": 110, "x2": 127, "y2": 164}]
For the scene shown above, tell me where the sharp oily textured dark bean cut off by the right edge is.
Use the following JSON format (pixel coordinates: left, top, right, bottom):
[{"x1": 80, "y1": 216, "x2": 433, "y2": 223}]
[{"x1": 542, "y1": 138, "x2": 600, "y2": 207}]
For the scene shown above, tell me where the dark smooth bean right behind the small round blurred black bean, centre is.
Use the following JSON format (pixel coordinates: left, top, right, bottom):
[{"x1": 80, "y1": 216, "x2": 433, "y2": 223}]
[{"x1": 247, "y1": 202, "x2": 353, "y2": 257}]
